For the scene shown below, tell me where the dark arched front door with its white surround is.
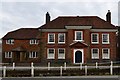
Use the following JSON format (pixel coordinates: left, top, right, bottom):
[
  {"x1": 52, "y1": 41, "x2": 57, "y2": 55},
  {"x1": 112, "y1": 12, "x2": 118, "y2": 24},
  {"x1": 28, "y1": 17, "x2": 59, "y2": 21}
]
[{"x1": 74, "y1": 49, "x2": 84, "y2": 64}]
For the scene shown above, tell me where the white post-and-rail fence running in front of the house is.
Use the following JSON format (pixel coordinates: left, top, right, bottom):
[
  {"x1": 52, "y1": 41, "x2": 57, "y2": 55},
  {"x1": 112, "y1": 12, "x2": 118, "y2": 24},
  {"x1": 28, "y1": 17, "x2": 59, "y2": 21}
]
[{"x1": 0, "y1": 61, "x2": 120, "y2": 77}]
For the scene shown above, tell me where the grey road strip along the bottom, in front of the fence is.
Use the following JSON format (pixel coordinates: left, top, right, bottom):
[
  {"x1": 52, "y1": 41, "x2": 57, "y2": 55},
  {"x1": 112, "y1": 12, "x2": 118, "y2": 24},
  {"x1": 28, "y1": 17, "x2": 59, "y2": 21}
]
[{"x1": 2, "y1": 76, "x2": 120, "y2": 80}]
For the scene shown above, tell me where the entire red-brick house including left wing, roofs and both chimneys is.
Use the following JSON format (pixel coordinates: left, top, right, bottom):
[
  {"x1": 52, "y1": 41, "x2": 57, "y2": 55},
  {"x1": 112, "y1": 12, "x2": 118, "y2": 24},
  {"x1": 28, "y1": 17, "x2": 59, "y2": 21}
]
[{"x1": 2, "y1": 11, "x2": 118, "y2": 64}]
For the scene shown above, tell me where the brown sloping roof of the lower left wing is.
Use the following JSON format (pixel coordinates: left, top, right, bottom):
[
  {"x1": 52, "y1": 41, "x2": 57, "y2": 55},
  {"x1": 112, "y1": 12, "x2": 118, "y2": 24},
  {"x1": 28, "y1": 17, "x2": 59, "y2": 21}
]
[{"x1": 2, "y1": 28, "x2": 39, "y2": 39}]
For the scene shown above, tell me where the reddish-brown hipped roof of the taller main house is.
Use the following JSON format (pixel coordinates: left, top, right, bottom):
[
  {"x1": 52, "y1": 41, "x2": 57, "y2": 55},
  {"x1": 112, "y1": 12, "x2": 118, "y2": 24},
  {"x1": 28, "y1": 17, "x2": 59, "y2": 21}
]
[{"x1": 39, "y1": 16, "x2": 116, "y2": 29}]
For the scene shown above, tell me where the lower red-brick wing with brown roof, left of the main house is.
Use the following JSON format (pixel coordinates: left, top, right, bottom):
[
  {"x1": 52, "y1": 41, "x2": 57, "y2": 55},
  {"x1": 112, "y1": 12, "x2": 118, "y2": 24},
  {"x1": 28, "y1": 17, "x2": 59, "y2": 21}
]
[{"x1": 2, "y1": 28, "x2": 40, "y2": 62}]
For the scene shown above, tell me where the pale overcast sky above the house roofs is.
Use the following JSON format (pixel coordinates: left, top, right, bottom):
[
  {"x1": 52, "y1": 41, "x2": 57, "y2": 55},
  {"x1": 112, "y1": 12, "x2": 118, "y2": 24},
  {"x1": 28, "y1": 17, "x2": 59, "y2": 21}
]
[{"x1": 0, "y1": 0, "x2": 120, "y2": 38}]
